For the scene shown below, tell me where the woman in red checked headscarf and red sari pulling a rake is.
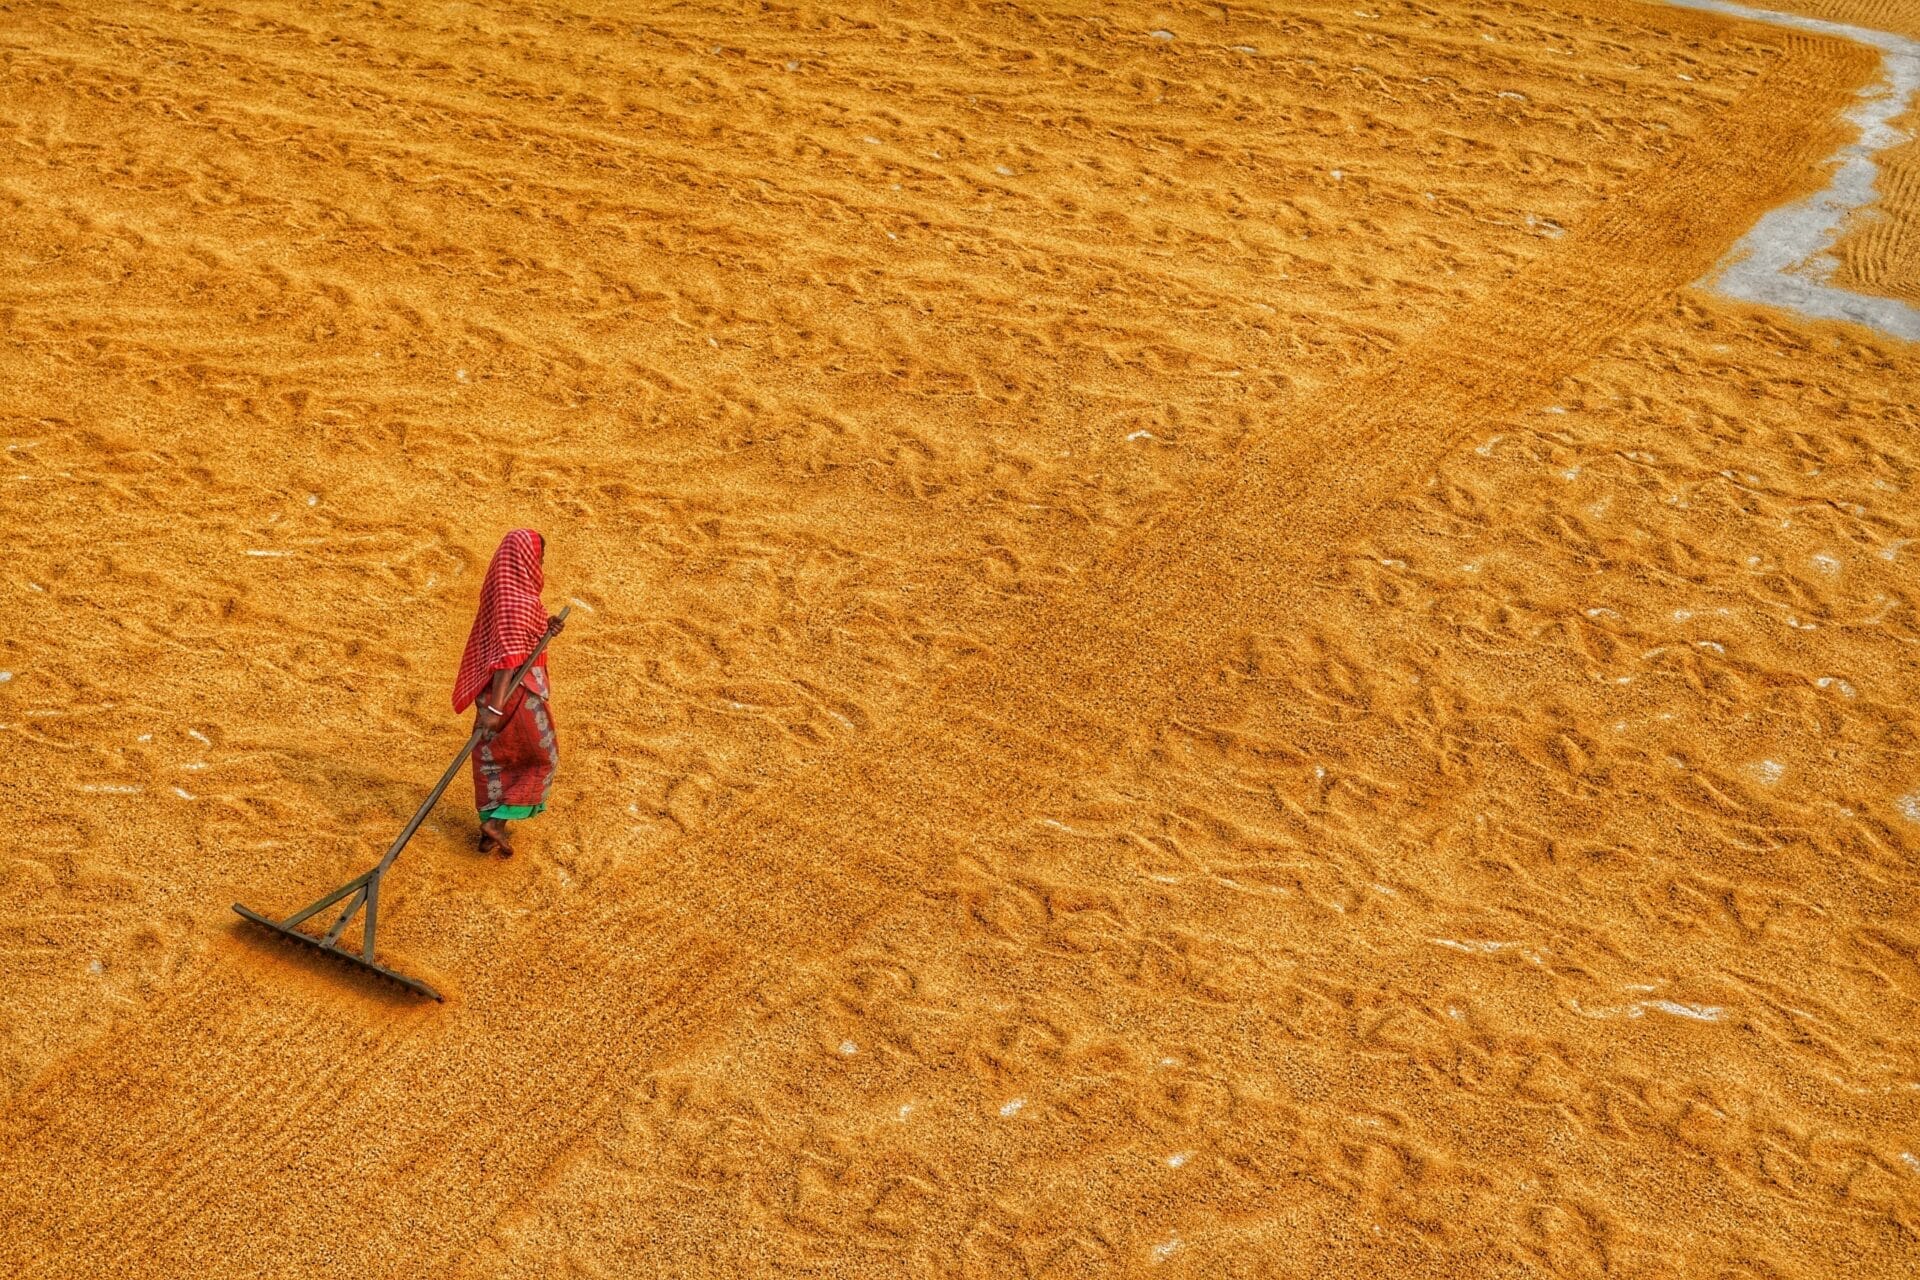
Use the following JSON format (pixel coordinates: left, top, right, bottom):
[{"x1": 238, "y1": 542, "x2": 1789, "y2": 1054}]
[{"x1": 453, "y1": 530, "x2": 561, "y2": 858}]
